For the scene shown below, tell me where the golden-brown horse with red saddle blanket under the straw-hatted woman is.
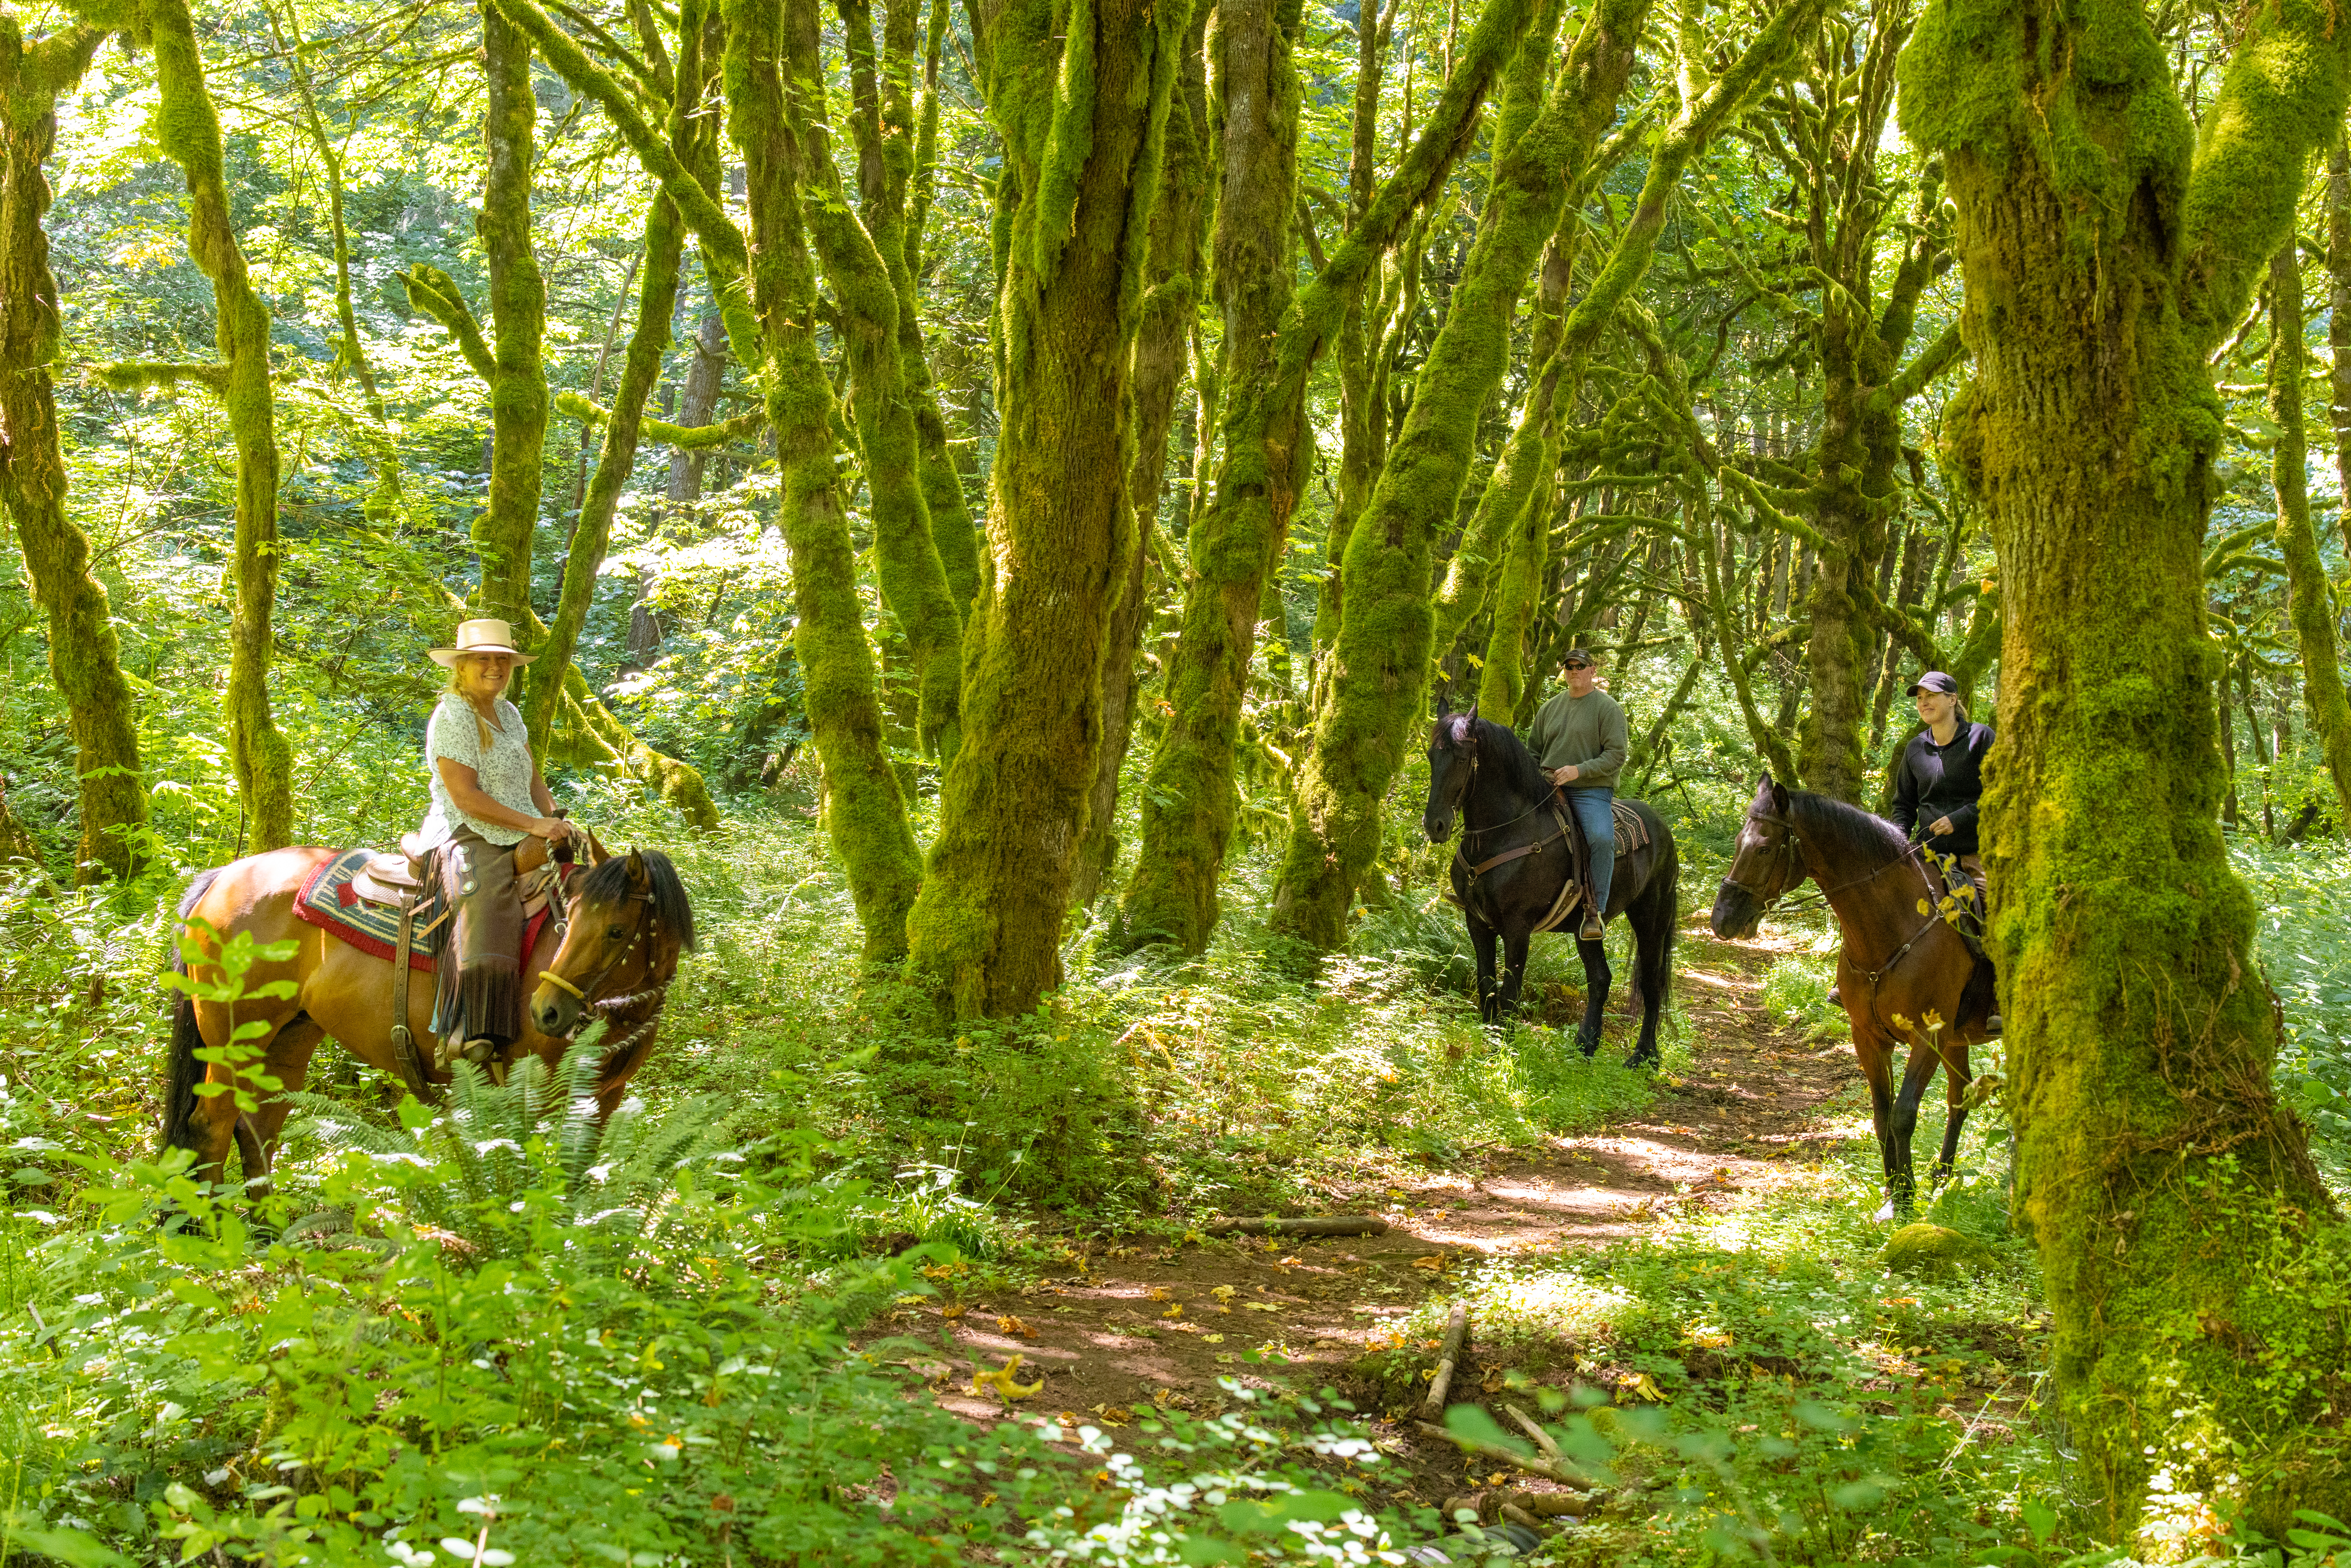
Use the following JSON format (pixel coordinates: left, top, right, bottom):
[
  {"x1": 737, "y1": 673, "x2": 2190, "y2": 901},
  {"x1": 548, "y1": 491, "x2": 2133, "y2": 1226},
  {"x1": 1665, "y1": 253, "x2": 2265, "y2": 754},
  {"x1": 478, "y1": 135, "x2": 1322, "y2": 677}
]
[{"x1": 162, "y1": 846, "x2": 694, "y2": 1194}]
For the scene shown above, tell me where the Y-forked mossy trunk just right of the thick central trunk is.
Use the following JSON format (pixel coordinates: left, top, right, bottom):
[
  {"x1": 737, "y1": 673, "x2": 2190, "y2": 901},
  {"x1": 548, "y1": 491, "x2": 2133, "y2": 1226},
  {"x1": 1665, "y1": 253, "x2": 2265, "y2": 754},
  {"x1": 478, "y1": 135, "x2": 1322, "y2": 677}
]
[{"x1": 1119, "y1": 0, "x2": 1559, "y2": 952}]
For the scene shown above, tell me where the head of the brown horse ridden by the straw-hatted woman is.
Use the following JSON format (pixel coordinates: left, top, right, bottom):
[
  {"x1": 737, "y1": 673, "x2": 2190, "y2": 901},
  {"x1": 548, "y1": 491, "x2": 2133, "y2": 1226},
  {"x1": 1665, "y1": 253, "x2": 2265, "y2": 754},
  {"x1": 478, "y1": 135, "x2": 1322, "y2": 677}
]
[{"x1": 531, "y1": 849, "x2": 694, "y2": 1039}]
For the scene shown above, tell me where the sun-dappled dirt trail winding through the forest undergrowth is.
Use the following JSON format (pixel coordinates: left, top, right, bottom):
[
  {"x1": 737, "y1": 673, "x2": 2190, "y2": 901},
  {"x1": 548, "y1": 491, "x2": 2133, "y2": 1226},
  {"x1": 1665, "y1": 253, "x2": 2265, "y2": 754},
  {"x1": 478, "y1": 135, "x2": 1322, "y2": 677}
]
[{"x1": 874, "y1": 914, "x2": 1860, "y2": 1460}]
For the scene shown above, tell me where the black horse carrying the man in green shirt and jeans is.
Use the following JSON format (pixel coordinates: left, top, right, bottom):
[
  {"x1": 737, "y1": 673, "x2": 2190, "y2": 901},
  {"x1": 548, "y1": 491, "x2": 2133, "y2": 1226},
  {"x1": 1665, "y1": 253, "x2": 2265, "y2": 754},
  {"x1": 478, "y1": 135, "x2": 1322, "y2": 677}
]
[{"x1": 1420, "y1": 708, "x2": 1681, "y2": 1067}]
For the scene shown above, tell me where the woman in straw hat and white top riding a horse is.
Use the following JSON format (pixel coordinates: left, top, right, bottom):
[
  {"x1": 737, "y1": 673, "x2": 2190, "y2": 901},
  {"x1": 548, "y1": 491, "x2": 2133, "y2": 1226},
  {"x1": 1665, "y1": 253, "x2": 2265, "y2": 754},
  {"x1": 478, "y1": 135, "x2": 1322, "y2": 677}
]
[{"x1": 423, "y1": 621, "x2": 578, "y2": 1065}]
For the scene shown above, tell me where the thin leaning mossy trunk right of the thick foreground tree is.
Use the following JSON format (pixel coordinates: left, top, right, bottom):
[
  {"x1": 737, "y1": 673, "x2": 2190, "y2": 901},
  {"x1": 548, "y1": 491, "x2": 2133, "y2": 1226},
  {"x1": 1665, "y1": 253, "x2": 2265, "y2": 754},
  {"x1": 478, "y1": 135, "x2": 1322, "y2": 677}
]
[{"x1": 2269, "y1": 235, "x2": 2351, "y2": 827}]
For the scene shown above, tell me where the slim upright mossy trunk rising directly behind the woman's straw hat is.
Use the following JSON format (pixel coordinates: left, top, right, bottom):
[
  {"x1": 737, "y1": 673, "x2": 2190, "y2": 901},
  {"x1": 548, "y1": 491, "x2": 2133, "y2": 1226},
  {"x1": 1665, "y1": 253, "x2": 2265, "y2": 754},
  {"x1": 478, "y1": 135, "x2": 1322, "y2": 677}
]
[{"x1": 472, "y1": 5, "x2": 548, "y2": 628}]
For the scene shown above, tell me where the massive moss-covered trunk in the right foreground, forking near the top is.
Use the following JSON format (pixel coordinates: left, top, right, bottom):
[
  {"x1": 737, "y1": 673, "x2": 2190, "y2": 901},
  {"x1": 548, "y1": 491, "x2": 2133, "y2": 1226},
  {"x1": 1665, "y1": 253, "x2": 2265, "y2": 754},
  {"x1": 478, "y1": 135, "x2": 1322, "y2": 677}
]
[{"x1": 1902, "y1": 0, "x2": 2351, "y2": 1545}]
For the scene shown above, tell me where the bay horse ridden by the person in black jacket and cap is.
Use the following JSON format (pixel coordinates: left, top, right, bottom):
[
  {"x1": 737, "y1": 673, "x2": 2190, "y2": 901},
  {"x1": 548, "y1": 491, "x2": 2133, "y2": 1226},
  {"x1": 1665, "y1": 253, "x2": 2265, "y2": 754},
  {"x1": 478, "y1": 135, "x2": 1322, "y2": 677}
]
[{"x1": 1711, "y1": 773, "x2": 1996, "y2": 1220}]
